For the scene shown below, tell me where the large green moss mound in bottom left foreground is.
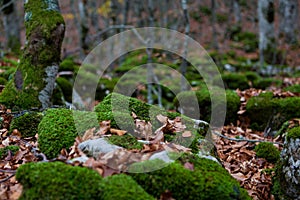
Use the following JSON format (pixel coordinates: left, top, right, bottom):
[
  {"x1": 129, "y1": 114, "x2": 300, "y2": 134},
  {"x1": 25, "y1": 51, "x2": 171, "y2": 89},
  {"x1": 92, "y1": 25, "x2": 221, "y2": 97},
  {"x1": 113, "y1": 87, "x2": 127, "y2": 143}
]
[{"x1": 16, "y1": 162, "x2": 102, "y2": 199}]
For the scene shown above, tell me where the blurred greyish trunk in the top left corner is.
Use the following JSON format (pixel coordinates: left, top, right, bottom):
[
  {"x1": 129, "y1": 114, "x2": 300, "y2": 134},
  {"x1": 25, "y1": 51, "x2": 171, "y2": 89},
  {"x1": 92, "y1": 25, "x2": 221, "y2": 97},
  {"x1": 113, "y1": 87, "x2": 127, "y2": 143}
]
[{"x1": 1, "y1": 0, "x2": 21, "y2": 52}]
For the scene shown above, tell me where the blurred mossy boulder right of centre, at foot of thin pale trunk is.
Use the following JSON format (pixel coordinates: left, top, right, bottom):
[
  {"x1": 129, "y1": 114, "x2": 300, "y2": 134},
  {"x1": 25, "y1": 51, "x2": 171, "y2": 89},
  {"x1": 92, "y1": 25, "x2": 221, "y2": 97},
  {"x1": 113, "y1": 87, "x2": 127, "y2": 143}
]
[{"x1": 174, "y1": 88, "x2": 240, "y2": 124}]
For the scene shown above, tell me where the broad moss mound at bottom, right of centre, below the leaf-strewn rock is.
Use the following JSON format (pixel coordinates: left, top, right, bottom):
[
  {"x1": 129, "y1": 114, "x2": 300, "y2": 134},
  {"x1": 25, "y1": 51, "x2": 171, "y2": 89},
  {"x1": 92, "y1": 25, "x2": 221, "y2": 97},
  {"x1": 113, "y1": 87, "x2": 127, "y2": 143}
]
[{"x1": 131, "y1": 158, "x2": 250, "y2": 200}]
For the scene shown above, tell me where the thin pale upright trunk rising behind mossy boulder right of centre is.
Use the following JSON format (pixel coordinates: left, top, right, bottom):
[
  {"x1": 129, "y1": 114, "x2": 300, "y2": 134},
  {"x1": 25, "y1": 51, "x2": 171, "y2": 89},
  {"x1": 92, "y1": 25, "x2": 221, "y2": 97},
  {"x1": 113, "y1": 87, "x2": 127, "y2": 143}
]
[{"x1": 180, "y1": 0, "x2": 190, "y2": 91}]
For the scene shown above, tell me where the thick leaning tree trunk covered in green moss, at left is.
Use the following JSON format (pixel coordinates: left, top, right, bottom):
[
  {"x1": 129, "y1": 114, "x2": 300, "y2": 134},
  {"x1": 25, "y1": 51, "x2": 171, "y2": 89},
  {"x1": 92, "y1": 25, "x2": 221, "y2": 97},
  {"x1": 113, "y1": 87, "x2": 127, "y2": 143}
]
[{"x1": 0, "y1": 0, "x2": 65, "y2": 109}]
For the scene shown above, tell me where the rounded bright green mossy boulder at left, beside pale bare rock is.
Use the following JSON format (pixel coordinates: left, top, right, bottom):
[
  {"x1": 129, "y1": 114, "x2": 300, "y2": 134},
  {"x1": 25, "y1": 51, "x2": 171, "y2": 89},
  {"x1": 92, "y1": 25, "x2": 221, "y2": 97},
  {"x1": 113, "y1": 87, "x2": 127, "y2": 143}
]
[{"x1": 38, "y1": 108, "x2": 99, "y2": 158}]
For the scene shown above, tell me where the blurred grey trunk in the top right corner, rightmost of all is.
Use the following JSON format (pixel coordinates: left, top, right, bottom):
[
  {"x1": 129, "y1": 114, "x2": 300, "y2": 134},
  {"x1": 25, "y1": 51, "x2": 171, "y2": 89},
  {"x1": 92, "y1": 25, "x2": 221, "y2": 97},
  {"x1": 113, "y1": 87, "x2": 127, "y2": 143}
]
[{"x1": 279, "y1": 0, "x2": 298, "y2": 44}]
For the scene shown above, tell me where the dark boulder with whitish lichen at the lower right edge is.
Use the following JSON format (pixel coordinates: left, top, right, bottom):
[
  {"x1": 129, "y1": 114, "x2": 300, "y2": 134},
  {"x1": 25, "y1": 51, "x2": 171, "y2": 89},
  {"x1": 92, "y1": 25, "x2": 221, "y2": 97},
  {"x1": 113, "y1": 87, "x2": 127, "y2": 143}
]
[{"x1": 273, "y1": 127, "x2": 300, "y2": 200}]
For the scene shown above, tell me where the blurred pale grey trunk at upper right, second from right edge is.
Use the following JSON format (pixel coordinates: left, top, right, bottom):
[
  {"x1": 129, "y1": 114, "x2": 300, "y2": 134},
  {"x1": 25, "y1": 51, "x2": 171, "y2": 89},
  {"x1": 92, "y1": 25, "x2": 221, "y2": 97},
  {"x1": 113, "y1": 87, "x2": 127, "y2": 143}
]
[{"x1": 257, "y1": 0, "x2": 276, "y2": 66}]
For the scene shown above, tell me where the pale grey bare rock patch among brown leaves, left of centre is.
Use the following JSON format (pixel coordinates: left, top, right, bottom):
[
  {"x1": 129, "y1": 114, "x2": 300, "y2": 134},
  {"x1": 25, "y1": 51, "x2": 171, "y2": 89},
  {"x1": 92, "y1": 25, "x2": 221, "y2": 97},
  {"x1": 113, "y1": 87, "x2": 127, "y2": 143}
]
[{"x1": 78, "y1": 138, "x2": 122, "y2": 158}]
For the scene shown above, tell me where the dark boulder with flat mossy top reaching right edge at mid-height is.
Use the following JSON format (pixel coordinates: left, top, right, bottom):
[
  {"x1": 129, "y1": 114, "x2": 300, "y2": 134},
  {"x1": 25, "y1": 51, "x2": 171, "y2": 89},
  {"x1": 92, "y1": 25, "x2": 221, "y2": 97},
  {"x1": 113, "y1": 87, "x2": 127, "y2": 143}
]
[{"x1": 246, "y1": 95, "x2": 300, "y2": 130}]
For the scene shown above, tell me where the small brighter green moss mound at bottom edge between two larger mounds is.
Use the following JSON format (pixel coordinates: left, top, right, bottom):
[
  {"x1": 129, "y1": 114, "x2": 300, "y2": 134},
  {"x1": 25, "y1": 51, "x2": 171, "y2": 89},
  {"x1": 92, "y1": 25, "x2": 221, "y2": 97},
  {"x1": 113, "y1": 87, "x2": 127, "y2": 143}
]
[{"x1": 100, "y1": 174, "x2": 154, "y2": 200}]
